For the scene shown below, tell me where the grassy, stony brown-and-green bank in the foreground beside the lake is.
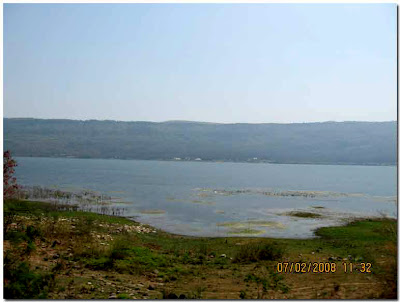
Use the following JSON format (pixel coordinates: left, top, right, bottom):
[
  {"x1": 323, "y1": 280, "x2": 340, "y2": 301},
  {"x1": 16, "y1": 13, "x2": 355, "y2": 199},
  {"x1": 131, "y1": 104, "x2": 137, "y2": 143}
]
[{"x1": 4, "y1": 200, "x2": 397, "y2": 299}]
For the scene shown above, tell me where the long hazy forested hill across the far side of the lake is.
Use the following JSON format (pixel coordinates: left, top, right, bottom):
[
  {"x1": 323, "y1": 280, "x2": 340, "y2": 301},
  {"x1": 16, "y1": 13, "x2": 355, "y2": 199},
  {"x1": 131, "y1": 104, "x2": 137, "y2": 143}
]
[{"x1": 4, "y1": 118, "x2": 397, "y2": 165}]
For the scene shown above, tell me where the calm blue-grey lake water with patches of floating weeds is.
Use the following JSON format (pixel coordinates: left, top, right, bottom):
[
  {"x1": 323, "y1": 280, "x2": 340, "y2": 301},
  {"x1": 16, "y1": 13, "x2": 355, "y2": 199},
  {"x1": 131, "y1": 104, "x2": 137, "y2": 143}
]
[{"x1": 16, "y1": 157, "x2": 397, "y2": 238}]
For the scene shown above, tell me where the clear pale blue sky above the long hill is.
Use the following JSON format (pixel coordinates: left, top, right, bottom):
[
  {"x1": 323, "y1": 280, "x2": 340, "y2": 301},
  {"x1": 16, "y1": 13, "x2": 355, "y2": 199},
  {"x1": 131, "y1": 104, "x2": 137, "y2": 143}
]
[{"x1": 3, "y1": 3, "x2": 397, "y2": 123}]
